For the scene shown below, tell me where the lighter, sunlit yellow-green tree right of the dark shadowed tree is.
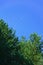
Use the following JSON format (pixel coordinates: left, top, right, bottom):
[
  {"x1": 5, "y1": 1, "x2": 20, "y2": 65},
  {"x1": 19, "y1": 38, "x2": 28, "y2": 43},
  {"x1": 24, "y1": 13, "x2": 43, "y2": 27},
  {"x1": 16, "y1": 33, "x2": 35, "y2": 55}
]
[{"x1": 19, "y1": 33, "x2": 41, "y2": 65}]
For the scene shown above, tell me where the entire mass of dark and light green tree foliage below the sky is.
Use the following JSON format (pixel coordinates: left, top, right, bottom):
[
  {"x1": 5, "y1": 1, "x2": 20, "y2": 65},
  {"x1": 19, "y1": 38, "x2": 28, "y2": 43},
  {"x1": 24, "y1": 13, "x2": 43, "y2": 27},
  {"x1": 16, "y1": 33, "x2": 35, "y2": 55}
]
[{"x1": 0, "y1": 19, "x2": 43, "y2": 65}]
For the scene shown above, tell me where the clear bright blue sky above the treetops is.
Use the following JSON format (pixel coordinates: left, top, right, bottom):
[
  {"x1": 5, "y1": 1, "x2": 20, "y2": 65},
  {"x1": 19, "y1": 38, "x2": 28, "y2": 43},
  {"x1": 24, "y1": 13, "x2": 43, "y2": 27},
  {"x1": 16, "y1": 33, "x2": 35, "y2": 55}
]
[{"x1": 0, "y1": 0, "x2": 43, "y2": 37}]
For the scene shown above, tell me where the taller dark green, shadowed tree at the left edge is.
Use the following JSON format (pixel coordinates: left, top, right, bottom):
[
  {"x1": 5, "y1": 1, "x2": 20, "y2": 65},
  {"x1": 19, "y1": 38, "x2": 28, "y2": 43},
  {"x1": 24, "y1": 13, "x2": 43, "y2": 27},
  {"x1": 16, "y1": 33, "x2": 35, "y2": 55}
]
[{"x1": 0, "y1": 19, "x2": 18, "y2": 65}]
